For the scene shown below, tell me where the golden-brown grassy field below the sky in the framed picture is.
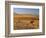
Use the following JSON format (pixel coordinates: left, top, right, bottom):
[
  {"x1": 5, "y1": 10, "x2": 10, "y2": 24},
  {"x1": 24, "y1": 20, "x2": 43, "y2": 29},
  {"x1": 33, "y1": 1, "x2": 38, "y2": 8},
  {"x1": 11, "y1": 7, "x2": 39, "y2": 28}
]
[{"x1": 14, "y1": 15, "x2": 39, "y2": 30}]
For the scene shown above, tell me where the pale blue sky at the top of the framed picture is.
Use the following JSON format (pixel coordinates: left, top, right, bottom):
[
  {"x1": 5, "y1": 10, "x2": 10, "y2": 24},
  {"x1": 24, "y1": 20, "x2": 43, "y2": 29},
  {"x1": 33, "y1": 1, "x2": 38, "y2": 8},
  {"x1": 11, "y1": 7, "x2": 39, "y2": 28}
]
[{"x1": 14, "y1": 8, "x2": 39, "y2": 15}]
